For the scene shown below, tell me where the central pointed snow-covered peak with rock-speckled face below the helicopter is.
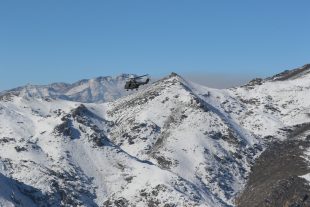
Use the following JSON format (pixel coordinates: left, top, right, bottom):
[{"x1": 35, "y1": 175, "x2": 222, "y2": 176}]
[{"x1": 107, "y1": 76, "x2": 261, "y2": 206}]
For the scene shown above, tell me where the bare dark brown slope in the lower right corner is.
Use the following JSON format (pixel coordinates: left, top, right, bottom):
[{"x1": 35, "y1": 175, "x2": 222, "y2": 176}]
[{"x1": 236, "y1": 137, "x2": 310, "y2": 207}]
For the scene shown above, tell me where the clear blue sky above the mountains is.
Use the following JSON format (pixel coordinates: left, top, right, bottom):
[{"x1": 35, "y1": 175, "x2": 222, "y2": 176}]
[{"x1": 0, "y1": 0, "x2": 310, "y2": 90}]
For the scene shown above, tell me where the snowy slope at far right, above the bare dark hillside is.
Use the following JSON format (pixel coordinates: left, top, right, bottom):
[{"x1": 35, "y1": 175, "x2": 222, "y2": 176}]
[{"x1": 222, "y1": 65, "x2": 310, "y2": 139}]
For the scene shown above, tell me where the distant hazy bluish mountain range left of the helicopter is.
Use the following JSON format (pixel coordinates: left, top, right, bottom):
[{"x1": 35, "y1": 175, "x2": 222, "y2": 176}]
[{"x1": 0, "y1": 74, "x2": 135, "y2": 103}]
